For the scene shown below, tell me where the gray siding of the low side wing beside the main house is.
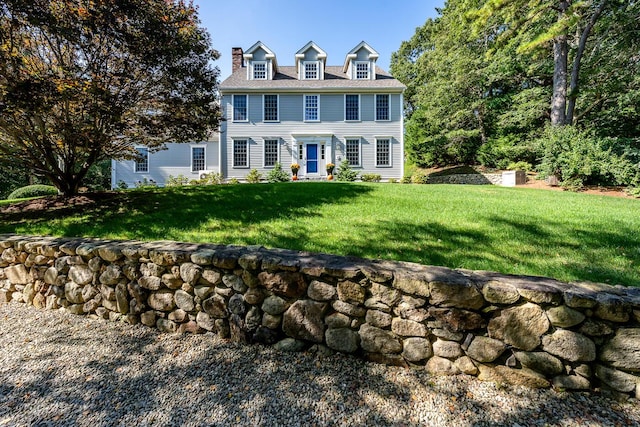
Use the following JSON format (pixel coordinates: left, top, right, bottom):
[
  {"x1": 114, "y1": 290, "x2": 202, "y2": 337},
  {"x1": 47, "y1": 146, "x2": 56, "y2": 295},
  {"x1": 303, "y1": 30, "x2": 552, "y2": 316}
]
[{"x1": 111, "y1": 142, "x2": 220, "y2": 188}]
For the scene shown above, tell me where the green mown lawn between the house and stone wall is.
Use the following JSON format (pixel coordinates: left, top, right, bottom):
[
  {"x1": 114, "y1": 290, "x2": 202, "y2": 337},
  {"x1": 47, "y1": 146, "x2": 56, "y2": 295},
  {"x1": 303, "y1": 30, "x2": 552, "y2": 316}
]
[{"x1": 0, "y1": 182, "x2": 640, "y2": 286}]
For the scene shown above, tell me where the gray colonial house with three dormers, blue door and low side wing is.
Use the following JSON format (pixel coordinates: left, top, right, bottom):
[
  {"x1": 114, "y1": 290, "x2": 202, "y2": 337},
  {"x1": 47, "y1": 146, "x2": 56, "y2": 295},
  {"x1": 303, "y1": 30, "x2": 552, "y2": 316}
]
[{"x1": 112, "y1": 42, "x2": 405, "y2": 188}]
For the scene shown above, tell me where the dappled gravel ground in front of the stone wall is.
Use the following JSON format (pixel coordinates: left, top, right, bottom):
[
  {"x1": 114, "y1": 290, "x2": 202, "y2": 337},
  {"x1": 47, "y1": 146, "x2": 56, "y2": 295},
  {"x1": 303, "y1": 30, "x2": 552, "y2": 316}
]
[{"x1": 0, "y1": 304, "x2": 640, "y2": 427}]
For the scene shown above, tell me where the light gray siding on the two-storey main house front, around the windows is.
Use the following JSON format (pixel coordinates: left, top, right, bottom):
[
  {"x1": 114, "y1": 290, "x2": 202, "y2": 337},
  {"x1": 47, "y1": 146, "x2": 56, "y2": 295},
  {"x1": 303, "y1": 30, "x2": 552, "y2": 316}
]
[{"x1": 220, "y1": 92, "x2": 403, "y2": 180}]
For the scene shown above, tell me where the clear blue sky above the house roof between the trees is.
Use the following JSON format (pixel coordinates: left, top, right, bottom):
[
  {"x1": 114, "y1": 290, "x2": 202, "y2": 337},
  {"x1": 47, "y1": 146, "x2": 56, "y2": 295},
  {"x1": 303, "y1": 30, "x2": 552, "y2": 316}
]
[{"x1": 194, "y1": 0, "x2": 445, "y2": 81}]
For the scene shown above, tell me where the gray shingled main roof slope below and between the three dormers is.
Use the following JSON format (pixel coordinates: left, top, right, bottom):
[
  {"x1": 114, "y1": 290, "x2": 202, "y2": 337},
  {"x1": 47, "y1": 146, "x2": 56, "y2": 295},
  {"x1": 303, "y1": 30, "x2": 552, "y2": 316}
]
[{"x1": 220, "y1": 66, "x2": 406, "y2": 92}]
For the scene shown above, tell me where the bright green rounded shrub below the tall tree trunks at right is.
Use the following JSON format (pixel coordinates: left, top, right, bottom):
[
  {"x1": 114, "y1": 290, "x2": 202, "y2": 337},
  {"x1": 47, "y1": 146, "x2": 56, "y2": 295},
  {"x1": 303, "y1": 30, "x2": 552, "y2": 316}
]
[{"x1": 538, "y1": 126, "x2": 640, "y2": 189}]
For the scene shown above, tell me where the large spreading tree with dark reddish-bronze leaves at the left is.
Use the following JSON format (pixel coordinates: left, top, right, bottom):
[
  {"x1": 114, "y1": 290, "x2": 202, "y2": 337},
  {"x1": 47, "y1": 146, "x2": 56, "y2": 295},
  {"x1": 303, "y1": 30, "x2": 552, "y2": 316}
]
[{"x1": 0, "y1": 0, "x2": 220, "y2": 195}]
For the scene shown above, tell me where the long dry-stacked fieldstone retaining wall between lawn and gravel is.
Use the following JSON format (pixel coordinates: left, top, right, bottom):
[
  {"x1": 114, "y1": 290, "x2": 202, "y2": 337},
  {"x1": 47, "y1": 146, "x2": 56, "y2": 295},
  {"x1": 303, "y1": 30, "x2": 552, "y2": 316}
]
[{"x1": 0, "y1": 235, "x2": 640, "y2": 398}]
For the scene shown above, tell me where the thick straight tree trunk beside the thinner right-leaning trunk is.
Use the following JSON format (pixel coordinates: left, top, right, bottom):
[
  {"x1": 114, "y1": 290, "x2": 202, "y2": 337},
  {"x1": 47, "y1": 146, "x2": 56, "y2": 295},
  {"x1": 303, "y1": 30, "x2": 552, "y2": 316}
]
[{"x1": 551, "y1": 0, "x2": 569, "y2": 126}]
